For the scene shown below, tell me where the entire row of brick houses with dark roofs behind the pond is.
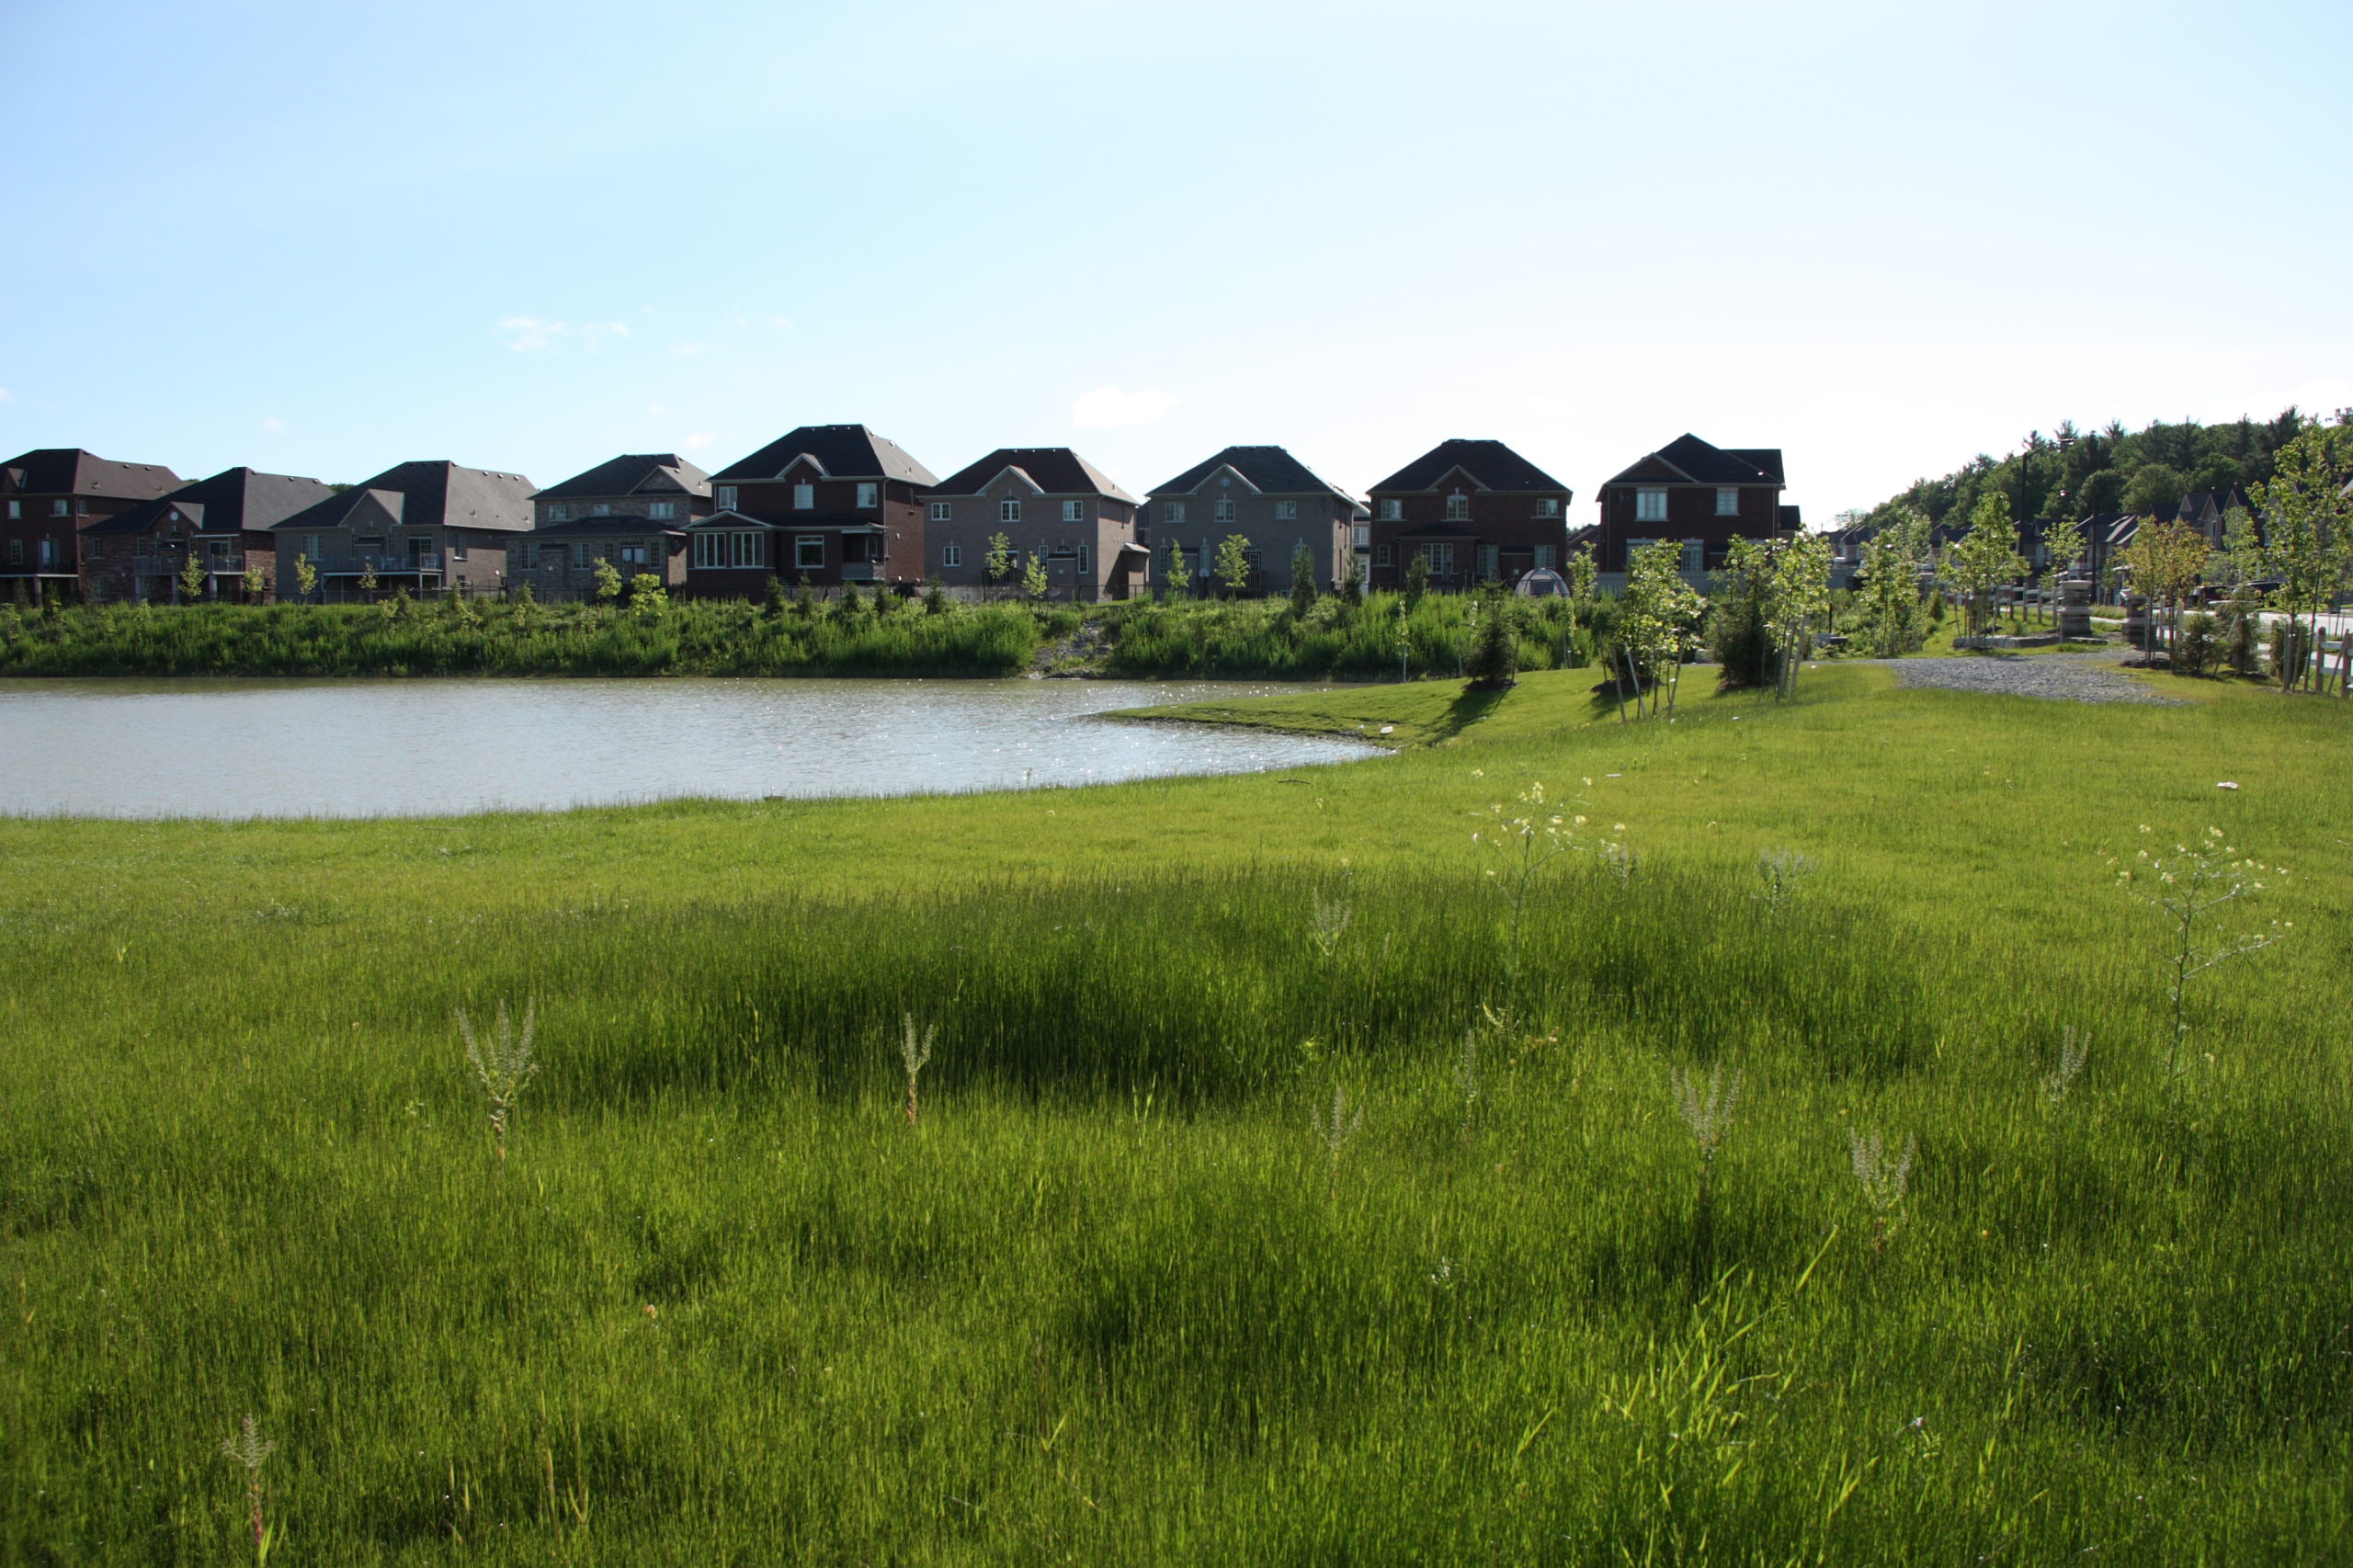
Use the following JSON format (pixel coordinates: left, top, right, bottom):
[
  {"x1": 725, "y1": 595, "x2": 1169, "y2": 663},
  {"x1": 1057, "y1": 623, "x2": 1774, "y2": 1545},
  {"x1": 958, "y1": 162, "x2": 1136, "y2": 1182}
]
[{"x1": 0, "y1": 424, "x2": 1798, "y2": 603}]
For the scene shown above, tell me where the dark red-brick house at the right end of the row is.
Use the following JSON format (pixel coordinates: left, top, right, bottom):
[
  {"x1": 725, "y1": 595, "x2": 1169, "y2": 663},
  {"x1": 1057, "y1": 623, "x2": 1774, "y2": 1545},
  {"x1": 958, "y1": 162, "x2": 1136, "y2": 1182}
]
[{"x1": 1593, "y1": 436, "x2": 1798, "y2": 584}]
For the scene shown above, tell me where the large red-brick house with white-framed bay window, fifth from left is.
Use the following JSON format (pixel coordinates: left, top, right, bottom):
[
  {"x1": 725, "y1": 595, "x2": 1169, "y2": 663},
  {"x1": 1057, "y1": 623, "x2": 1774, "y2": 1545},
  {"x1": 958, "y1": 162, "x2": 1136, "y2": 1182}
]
[{"x1": 688, "y1": 424, "x2": 937, "y2": 598}]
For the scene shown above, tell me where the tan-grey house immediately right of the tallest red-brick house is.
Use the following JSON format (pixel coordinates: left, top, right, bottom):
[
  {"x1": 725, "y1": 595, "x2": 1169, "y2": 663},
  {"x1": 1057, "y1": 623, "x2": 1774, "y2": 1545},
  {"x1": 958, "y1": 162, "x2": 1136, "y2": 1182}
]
[{"x1": 925, "y1": 448, "x2": 1148, "y2": 600}]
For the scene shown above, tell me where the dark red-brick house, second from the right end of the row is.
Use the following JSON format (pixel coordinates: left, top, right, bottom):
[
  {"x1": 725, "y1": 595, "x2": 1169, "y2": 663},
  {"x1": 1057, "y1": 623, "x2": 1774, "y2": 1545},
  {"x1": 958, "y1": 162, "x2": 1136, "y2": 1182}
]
[{"x1": 1371, "y1": 440, "x2": 1572, "y2": 588}]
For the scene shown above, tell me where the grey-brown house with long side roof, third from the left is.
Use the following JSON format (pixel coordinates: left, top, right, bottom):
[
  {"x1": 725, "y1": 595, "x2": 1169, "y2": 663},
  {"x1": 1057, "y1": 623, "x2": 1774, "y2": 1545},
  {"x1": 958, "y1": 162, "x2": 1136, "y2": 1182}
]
[{"x1": 270, "y1": 461, "x2": 532, "y2": 600}]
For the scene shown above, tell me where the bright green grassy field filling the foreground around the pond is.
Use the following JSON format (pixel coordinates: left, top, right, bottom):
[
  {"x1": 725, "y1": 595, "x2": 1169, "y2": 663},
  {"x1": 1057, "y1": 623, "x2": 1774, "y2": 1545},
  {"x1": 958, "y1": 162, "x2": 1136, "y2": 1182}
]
[{"x1": 0, "y1": 666, "x2": 2353, "y2": 1565}]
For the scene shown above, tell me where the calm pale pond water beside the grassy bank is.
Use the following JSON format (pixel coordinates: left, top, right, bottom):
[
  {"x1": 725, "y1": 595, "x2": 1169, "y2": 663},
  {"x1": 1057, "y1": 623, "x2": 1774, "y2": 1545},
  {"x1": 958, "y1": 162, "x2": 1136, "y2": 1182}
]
[{"x1": 0, "y1": 680, "x2": 1377, "y2": 817}]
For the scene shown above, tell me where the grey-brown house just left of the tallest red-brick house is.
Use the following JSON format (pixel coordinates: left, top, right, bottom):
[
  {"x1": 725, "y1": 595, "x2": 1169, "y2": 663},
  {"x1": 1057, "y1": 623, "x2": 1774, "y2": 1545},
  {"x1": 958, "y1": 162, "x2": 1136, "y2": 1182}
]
[{"x1": 524, "y1": 452, "x2": 713, "y2": 603}]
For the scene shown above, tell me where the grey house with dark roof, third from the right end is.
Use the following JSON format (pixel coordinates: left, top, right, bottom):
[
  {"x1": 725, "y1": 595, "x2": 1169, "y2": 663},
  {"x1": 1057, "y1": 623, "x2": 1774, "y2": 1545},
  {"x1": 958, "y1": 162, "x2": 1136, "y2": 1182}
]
[{"x1": 1139, "y1": 448, "x2": 1371, "y2": 594}]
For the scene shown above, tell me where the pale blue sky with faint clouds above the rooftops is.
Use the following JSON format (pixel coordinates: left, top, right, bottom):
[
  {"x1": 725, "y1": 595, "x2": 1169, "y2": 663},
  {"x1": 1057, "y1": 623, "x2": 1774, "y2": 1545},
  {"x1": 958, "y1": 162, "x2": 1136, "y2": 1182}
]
[{"x1": 0, "y1": 0, "x2": 2353, "y2": 523}]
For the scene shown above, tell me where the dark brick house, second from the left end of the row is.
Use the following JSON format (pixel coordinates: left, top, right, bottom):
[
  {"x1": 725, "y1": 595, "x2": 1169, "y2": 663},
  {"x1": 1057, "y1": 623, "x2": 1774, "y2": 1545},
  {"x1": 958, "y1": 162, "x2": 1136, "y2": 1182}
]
[{"x1": 83, "y1": 469, "x2": 335, "y2": 603}]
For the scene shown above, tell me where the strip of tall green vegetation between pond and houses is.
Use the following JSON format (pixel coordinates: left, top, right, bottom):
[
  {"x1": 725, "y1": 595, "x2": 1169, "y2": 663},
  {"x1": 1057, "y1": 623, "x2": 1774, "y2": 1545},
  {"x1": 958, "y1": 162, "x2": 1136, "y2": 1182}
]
[{"x1": 0, "y1": 594, "x2": 1567, "y2": 680}]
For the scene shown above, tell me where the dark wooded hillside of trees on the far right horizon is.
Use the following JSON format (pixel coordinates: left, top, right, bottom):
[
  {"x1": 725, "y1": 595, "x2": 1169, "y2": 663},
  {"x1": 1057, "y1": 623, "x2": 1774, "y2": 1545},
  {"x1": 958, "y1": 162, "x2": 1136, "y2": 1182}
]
[{"x1": 1840, "y1": 407, "x2": 2346, "y2": 525}]
